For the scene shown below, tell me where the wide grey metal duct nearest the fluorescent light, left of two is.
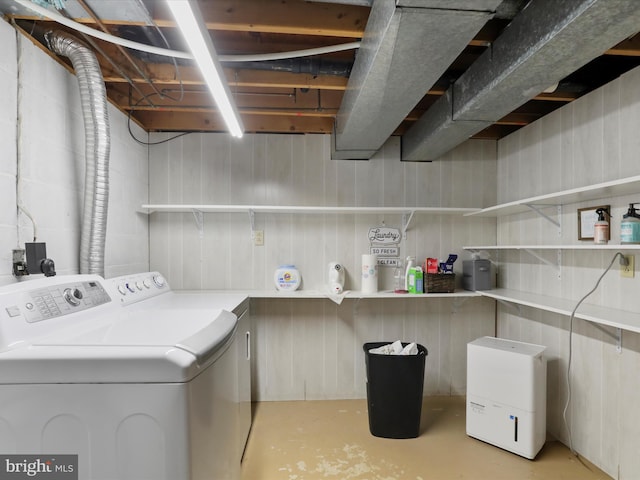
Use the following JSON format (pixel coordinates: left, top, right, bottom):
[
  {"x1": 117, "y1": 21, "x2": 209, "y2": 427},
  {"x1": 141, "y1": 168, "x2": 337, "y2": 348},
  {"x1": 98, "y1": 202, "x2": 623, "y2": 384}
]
[{"x1": 332, "y1": 0, "x2": 502, "y2": 159}]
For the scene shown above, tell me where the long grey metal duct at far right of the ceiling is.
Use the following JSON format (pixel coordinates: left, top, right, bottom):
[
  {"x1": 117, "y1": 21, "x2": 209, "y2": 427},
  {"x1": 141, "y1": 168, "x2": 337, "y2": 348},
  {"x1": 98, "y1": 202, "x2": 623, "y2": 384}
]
[{"x1": 402, "y1": 0, "x2": 640, "y2": 161}]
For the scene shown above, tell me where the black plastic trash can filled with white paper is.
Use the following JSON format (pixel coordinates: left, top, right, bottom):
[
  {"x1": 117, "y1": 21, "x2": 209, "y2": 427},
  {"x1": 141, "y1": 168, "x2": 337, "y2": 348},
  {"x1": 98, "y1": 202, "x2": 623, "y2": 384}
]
[{"x1": 362, "y1": 342, "x2": 427, "y2": 438}]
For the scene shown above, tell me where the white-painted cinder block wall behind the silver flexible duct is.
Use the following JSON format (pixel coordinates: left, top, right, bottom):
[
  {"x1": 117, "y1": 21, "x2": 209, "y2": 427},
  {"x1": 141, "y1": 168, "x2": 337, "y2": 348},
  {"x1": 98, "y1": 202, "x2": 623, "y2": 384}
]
[{"x1": 0, "y1": 20, "x2": 149, "y2": 285}]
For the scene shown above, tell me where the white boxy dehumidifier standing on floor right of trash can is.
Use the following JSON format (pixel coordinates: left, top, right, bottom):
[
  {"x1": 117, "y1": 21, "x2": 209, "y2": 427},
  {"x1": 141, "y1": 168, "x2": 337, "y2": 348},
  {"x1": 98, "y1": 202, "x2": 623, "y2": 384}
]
[{"x1": 467, "y1": 337, "x2": 547, "y2": 459}]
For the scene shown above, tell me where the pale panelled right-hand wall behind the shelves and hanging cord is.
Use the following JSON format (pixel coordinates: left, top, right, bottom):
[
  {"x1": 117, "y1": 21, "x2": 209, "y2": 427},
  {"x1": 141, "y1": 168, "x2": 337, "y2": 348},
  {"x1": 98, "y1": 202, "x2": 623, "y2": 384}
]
[{"x1": 497, "y1": 64, "x2": 640, "y2": 480}]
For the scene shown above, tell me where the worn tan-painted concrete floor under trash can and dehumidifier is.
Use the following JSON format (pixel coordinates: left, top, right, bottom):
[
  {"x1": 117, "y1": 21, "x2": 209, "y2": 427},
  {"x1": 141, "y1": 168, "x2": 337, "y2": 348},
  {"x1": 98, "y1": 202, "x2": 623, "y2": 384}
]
[{"x1": 242, "y1": 397, "x2": 611, "y2": 480}]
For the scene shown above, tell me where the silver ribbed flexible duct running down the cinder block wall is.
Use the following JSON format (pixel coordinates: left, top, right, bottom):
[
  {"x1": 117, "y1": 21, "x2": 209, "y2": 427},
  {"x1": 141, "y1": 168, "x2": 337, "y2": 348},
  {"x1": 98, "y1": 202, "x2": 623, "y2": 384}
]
[{"x1": 45, "y1": 32, "x2": 111, "y2": 277}]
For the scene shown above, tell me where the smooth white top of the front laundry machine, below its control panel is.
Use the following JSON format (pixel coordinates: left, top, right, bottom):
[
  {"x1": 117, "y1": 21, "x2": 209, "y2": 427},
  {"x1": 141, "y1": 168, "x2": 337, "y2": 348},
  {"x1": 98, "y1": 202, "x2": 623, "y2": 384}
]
[{"x1": 0, "y1": 309, "x2": 237, "y2": 384}]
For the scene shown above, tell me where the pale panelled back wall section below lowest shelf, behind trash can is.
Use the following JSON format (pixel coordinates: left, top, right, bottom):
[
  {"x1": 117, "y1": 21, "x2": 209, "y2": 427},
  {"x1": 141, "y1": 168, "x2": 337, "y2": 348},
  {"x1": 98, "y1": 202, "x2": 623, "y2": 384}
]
[{"x1": 251, "y1": 299, "x2": 494, "y2": 401}]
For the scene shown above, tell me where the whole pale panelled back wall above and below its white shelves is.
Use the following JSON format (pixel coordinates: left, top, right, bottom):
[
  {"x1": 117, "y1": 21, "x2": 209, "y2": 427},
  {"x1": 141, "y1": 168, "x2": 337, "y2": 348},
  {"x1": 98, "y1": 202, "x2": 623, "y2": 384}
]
[{"x1": 149, "y1": 134, "x2": 496, "y2": 400}]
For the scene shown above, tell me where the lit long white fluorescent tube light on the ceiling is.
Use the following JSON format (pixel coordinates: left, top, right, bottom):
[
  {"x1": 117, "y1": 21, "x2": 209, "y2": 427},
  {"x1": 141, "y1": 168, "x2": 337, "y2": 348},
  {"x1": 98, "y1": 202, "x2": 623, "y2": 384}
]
[{"x1": 167, "y1": 0, "x2": 244, "y2": 138}]
